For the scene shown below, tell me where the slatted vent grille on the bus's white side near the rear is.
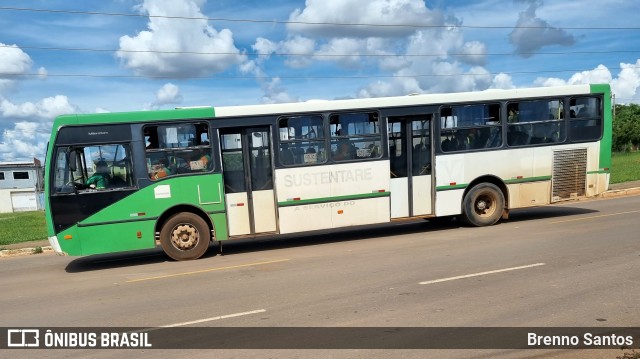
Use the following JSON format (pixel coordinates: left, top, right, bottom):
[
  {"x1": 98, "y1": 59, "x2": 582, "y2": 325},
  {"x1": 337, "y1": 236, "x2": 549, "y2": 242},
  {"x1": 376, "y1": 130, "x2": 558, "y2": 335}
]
[{"x1": 551, "y1": 148, "x2": 587, "y2": 202}]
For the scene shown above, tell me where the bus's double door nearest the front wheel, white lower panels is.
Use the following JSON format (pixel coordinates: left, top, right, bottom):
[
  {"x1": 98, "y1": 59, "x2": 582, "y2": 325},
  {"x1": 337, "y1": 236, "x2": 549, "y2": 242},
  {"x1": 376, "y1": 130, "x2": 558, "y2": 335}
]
[{"x1": 220, "y1": 127, "x2": 276, "y2": 236}]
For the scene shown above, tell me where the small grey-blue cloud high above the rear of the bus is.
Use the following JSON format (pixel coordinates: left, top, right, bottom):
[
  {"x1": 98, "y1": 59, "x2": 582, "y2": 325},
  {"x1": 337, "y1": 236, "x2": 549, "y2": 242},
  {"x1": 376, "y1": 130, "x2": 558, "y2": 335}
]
[{"x1": 509, "y1": 0, "x2": 576, "y2": 57}]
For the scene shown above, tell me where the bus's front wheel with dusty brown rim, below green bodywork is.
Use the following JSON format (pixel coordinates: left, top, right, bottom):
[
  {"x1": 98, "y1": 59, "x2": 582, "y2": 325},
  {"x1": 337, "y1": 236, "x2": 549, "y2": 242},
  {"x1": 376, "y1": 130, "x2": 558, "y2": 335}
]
[{"x1": 160, "y1": 212, "x2": 211, "y2": 261}]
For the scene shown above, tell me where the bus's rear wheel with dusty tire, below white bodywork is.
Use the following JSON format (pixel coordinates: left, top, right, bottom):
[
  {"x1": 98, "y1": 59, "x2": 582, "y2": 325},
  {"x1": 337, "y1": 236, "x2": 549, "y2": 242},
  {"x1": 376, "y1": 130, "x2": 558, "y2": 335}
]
[{"x1": 462, "y1": 183, "x2": 505, "y2": 227}]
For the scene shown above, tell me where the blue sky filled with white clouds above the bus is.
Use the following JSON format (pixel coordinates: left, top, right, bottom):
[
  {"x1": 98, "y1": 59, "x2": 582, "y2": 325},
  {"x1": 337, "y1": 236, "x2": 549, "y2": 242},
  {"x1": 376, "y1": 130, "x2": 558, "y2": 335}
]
[{"x1": 0, "y1": 0, "x2": 640, "y2": 162}]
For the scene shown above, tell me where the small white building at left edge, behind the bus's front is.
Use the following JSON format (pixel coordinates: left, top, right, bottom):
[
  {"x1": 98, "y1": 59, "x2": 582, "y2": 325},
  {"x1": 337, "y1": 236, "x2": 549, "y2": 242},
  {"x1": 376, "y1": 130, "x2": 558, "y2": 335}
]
[{"x1": 0, "y1": 158, "x2": 44, "y2": 213}]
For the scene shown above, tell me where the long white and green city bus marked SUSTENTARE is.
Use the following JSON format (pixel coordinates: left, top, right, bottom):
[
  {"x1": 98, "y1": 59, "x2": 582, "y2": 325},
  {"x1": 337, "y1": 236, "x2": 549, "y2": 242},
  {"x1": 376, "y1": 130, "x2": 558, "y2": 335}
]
[{"x1": 45, "y1": 85, "x2": 612, "y2": 260}]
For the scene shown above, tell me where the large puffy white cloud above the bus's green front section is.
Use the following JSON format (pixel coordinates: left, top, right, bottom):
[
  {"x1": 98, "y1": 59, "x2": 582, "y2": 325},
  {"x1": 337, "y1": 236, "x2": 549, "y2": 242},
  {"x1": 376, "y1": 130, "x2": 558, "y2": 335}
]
[{"x1": 116, "y1": 0, "x2": 246, "y2": 78}]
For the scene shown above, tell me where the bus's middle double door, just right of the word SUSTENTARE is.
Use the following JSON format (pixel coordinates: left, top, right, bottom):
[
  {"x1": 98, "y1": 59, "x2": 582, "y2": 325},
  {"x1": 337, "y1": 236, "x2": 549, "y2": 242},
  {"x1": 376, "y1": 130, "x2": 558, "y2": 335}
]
[{"x1": 388, "y1": 114, "x2": 433, "y2": 218}]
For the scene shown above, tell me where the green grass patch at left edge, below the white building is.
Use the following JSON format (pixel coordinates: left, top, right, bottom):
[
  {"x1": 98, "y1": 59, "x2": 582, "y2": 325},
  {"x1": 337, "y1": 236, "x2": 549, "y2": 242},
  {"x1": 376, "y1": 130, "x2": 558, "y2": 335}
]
[{"x1": 0, "y1": 211, "x2": 47, "y2": 248}]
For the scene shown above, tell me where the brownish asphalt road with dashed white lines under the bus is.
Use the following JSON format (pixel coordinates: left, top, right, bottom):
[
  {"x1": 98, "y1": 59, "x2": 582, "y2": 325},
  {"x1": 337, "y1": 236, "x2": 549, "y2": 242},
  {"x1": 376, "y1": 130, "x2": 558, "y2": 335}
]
[{"x1": 0, "y1": 196, "x2": 640, "y2": 358}]
